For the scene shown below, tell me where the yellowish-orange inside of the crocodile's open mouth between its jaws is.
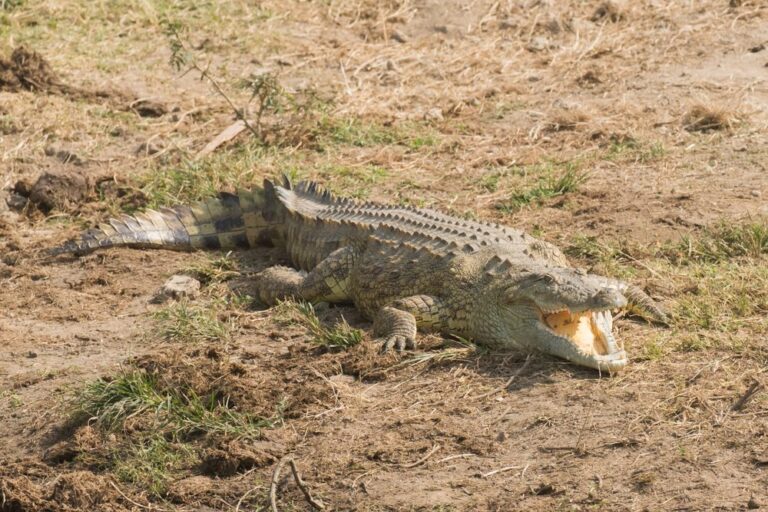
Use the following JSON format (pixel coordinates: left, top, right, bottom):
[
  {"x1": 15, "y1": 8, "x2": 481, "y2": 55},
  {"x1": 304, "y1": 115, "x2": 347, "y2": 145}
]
[{"x1": 543, "y1": 310, "x2": 623, "y2": 356}]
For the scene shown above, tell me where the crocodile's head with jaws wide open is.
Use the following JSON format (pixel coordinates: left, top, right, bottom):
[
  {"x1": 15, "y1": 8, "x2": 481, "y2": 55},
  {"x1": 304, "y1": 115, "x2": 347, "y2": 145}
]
[{"x1": 491, "y1": 267, "x2": 627, "y2": 372}]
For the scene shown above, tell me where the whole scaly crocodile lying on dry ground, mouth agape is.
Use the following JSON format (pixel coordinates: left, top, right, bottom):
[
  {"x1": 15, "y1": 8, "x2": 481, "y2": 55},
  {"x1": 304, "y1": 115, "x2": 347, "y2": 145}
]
[{"x1": 50, "y1": 177, "x2": 666, "y2": 372}]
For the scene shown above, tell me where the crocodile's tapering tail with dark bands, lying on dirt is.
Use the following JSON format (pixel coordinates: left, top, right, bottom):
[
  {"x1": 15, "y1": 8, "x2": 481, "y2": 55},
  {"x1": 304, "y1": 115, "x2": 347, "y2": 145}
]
[{"x1": 48, "y1": 186, "x2": 274, "y2": 256}]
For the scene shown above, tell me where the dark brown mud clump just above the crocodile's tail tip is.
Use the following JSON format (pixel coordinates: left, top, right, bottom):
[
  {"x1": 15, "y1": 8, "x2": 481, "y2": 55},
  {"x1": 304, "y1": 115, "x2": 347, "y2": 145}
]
[{"x1": 29, "y1": 172, "x2": 94, "y2": 213}]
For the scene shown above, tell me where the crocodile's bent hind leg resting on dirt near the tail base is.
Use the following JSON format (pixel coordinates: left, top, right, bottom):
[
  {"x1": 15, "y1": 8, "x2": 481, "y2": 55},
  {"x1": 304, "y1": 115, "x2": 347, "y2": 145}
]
[{"x1": 256, "y1": 247, "x2": 356, "y2": 305}]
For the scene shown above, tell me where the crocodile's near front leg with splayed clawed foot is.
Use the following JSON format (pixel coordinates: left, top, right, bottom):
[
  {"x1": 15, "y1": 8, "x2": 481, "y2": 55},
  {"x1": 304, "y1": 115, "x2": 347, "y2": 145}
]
[{"x1": 373, "y1": 295, "x2": 446, "y2": 352}]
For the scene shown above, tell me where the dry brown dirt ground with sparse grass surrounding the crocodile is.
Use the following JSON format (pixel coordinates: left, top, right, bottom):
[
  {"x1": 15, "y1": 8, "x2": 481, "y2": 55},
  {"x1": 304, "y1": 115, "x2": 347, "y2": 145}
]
[{"x1": 0, "y1": 0, "x2": 768, "y2": 512}]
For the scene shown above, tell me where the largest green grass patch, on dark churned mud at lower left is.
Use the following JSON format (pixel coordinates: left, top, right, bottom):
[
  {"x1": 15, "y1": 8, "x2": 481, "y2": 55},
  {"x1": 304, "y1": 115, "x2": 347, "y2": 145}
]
[{"x1": 71, "y1": 370, "x2": 274, "y2": 496}]
